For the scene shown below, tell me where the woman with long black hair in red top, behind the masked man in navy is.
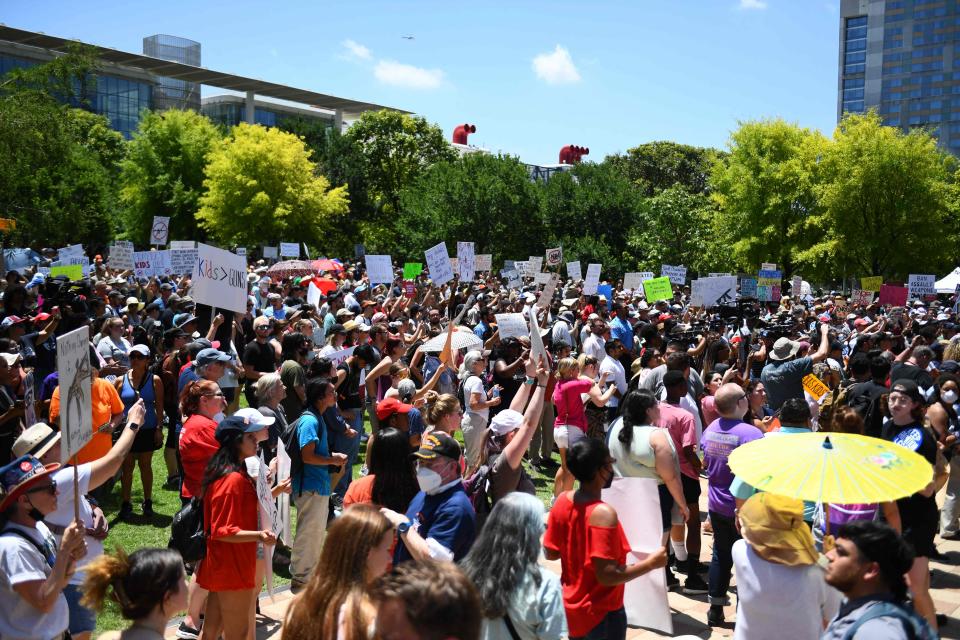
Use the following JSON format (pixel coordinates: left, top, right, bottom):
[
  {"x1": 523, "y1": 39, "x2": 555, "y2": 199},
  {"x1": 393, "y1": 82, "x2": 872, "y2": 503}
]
[{"x1": 343, "y1": 427, "x2": 420, "y2": 513}]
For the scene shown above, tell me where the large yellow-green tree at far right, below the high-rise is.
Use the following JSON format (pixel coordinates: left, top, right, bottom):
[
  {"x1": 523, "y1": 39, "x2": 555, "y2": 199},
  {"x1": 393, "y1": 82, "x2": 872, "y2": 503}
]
[{"x1": 797, "y1": 113, "x2": 958, "y2": 279}]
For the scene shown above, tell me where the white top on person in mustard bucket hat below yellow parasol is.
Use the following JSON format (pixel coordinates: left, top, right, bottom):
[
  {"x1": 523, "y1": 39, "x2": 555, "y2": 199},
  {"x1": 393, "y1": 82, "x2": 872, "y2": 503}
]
[{"x1": 733, "y1": 540, "x2": 841, "y2": 640}]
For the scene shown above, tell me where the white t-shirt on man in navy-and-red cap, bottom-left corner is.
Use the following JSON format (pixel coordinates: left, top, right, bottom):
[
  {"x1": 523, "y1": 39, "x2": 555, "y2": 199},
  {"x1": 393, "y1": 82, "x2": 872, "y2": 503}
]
[{"x1": 0, "y1": 522, "x2": 70, "y2": 640}]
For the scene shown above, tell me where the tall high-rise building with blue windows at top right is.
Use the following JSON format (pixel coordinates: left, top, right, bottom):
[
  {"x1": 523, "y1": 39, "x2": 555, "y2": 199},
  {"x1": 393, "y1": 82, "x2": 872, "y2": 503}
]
[{"x1": 837, "y1": 0, "x2": 960, "y2": 154}]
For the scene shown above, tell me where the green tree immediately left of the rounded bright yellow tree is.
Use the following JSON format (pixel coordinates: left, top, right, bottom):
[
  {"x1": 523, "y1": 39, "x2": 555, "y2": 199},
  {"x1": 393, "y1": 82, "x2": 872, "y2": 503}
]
[{"x1": 120, "y1": 109, "x2": 223, "y2": 244}]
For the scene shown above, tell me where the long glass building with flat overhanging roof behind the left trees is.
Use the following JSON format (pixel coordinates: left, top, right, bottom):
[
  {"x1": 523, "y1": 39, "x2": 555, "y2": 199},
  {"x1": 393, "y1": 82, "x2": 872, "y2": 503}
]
[{"x1": 0, "y1": 24, "x2": 408, "y2": 138}]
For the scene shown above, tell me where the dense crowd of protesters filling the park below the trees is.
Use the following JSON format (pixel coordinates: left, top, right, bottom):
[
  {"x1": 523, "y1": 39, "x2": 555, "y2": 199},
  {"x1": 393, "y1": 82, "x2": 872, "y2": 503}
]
[{"x1": 0, "y1": 251, "x2": 960, "y2": 640}]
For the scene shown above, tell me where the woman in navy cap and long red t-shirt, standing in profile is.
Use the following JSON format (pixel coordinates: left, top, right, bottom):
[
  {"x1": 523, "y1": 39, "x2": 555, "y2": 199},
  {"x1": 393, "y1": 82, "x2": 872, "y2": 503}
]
[{"x1": 197, "y1": 416, "x2": 277, "y2": 640}]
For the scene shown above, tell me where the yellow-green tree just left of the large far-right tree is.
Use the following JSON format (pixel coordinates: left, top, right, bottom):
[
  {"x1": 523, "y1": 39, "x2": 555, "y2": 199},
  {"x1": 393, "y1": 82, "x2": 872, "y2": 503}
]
[{"x1": 710, "y1": 119, "x2": 823, "y2": 274}]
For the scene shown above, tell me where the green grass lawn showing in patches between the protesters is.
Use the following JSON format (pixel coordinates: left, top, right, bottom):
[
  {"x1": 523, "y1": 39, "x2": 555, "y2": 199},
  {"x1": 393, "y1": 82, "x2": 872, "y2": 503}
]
[{"x1": 94, "y1": 410, "x2": 557, "y2": 635}]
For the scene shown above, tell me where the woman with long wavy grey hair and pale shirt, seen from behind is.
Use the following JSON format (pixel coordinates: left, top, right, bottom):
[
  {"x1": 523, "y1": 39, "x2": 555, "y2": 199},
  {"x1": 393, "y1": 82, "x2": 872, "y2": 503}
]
[{"x1": 460, "y1": 492, "x2": 567, "y2": 640}]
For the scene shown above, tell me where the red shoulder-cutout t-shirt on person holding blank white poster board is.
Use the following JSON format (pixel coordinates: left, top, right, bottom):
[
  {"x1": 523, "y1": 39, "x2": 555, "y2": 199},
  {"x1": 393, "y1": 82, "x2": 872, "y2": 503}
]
[{"x1": 543, "y1": 491, "x2": 630, "y2": 637}]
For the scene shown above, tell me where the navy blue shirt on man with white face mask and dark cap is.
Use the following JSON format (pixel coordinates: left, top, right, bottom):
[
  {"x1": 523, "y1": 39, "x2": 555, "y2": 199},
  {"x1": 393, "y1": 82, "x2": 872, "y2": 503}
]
[{"x1": 394, "y1": 482, "x2": 477, "y2": 564}]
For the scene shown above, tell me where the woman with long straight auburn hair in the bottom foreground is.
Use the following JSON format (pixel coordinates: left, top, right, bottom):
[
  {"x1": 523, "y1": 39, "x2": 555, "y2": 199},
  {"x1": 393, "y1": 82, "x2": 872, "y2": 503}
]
[{"x1": 282, "y1": 504, "x2": 394, "y2": 640}]
